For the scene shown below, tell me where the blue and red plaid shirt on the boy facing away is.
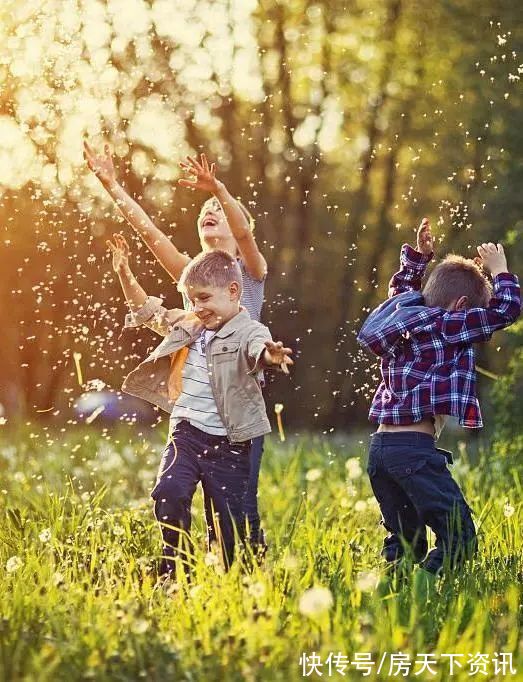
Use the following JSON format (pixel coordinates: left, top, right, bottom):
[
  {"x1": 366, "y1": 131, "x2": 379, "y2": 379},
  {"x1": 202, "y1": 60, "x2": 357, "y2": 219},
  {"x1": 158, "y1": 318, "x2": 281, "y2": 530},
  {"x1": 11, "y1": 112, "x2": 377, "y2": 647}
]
[{"x1": 358, "y1": 244, "x2": 521, "y2": 428}]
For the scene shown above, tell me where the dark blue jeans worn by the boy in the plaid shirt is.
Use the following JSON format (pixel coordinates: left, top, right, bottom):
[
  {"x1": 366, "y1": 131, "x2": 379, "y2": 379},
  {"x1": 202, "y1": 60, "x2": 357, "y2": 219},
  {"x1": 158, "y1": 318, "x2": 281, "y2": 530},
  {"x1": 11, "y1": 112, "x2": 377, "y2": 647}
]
[{"x1": 367, "y1": 431, "x2": 477, "y2": 573}]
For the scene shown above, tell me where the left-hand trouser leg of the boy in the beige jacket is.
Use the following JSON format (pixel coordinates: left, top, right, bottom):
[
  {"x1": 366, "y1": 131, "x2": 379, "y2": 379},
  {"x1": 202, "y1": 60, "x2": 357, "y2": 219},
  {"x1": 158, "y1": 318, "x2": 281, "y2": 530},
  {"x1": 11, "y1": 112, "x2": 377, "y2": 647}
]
[{"x1": 151, "y1": 422, "x2": 200, "y2": 574}]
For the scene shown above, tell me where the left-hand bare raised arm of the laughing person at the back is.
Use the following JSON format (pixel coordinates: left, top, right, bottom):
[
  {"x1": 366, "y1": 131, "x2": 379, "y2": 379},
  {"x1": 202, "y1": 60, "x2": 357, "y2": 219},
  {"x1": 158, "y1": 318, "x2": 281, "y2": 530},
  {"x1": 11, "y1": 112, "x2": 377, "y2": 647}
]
[{"x1": 84, "y1": 141, "x2": 191, "y2": 282}]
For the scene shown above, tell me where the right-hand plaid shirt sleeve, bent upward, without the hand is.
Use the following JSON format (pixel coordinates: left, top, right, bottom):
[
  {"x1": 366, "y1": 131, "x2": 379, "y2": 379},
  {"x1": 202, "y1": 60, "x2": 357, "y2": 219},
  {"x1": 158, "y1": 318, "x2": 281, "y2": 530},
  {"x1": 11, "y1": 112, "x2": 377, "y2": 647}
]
[{"x1": 441, "y1": 272, "x2": 521, "y2": 344}]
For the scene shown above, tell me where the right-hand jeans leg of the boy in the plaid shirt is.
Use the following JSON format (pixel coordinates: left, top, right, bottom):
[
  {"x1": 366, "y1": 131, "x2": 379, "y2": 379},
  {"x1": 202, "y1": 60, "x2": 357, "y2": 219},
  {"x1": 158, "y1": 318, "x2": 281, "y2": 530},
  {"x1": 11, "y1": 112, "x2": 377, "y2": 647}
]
[{"x1": 382, "y1": 444, "x2": 476, "y2": 573}]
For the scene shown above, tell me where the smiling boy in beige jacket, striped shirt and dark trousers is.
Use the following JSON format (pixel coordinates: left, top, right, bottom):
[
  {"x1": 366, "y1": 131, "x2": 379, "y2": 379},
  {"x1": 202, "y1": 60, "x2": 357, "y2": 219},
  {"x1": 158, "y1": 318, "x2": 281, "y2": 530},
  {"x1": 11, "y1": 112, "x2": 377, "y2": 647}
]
[{"x1": 108, "y1": 235, "x2": 293, "y2": 574}]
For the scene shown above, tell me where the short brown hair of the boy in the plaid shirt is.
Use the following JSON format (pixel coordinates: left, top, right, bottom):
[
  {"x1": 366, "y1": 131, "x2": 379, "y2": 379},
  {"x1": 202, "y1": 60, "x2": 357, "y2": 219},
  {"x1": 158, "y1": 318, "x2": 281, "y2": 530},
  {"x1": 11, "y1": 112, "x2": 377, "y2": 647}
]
[{"x1": 423, "y1": 253, "x2": 492, "y2": 308}]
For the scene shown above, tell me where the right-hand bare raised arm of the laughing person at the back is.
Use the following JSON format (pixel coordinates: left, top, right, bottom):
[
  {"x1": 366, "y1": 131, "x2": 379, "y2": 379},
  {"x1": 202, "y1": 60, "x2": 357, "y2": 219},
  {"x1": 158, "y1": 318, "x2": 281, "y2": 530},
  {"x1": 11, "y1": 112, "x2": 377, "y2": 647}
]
[{"x1": 178, "y1": 154, "x2": 267, "y2": 280}]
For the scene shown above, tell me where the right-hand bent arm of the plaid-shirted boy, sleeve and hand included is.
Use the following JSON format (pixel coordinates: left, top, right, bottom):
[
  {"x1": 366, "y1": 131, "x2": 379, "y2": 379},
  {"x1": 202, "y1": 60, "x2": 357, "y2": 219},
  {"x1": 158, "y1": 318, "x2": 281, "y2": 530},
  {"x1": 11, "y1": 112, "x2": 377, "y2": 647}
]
[{"x1": 441, "y1": 243, "x2": 521, "y2": 344}]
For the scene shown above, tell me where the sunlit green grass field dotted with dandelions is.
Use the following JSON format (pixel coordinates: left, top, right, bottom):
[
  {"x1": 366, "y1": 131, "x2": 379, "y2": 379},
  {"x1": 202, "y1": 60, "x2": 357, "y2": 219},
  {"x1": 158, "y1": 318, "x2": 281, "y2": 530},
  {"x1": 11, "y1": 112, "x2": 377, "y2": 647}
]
[{"x1": 0, "y1": 427, "x2": 523, "y2": 682}]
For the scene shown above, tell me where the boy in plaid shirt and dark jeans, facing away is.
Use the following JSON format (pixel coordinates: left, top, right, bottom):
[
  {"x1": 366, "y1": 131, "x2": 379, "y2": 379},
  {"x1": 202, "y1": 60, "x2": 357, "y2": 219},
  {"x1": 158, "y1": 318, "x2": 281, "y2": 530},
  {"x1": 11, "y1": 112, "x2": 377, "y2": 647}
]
[{"x1": 358, "y1": 219, "x2": 521, "y2": 574}]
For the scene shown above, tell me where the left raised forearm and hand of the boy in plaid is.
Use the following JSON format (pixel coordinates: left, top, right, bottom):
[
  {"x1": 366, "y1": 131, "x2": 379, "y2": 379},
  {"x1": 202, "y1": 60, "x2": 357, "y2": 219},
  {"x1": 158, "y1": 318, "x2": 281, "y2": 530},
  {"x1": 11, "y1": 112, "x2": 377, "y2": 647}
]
[{"x1": 389, "y1": 218, "x2": 434, "y2": 298}]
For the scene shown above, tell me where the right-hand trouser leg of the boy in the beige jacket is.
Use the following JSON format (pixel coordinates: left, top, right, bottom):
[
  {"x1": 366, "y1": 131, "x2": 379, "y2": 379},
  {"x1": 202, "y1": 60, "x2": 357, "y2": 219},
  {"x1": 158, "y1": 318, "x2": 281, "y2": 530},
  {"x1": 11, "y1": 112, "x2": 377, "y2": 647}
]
[{"x1": 201, "y1": 436, "x2": 250, "y2": 568}]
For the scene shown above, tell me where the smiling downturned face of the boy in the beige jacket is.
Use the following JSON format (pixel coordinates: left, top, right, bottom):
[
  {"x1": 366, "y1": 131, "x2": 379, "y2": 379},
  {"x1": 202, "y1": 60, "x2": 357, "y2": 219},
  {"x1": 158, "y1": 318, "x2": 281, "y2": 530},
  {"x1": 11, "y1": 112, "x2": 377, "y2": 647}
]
[{"x1": 185, "y1": 282, "x2": 241, "y2": 329}]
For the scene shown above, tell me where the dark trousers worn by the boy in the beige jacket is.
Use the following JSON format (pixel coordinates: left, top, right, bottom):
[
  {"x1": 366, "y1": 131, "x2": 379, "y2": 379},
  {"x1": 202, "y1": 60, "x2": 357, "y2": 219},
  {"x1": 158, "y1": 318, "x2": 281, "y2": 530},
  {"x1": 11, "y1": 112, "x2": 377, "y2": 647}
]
[{"x1": 151, "y1": 420, "x2": 251, "y2": 573}]
